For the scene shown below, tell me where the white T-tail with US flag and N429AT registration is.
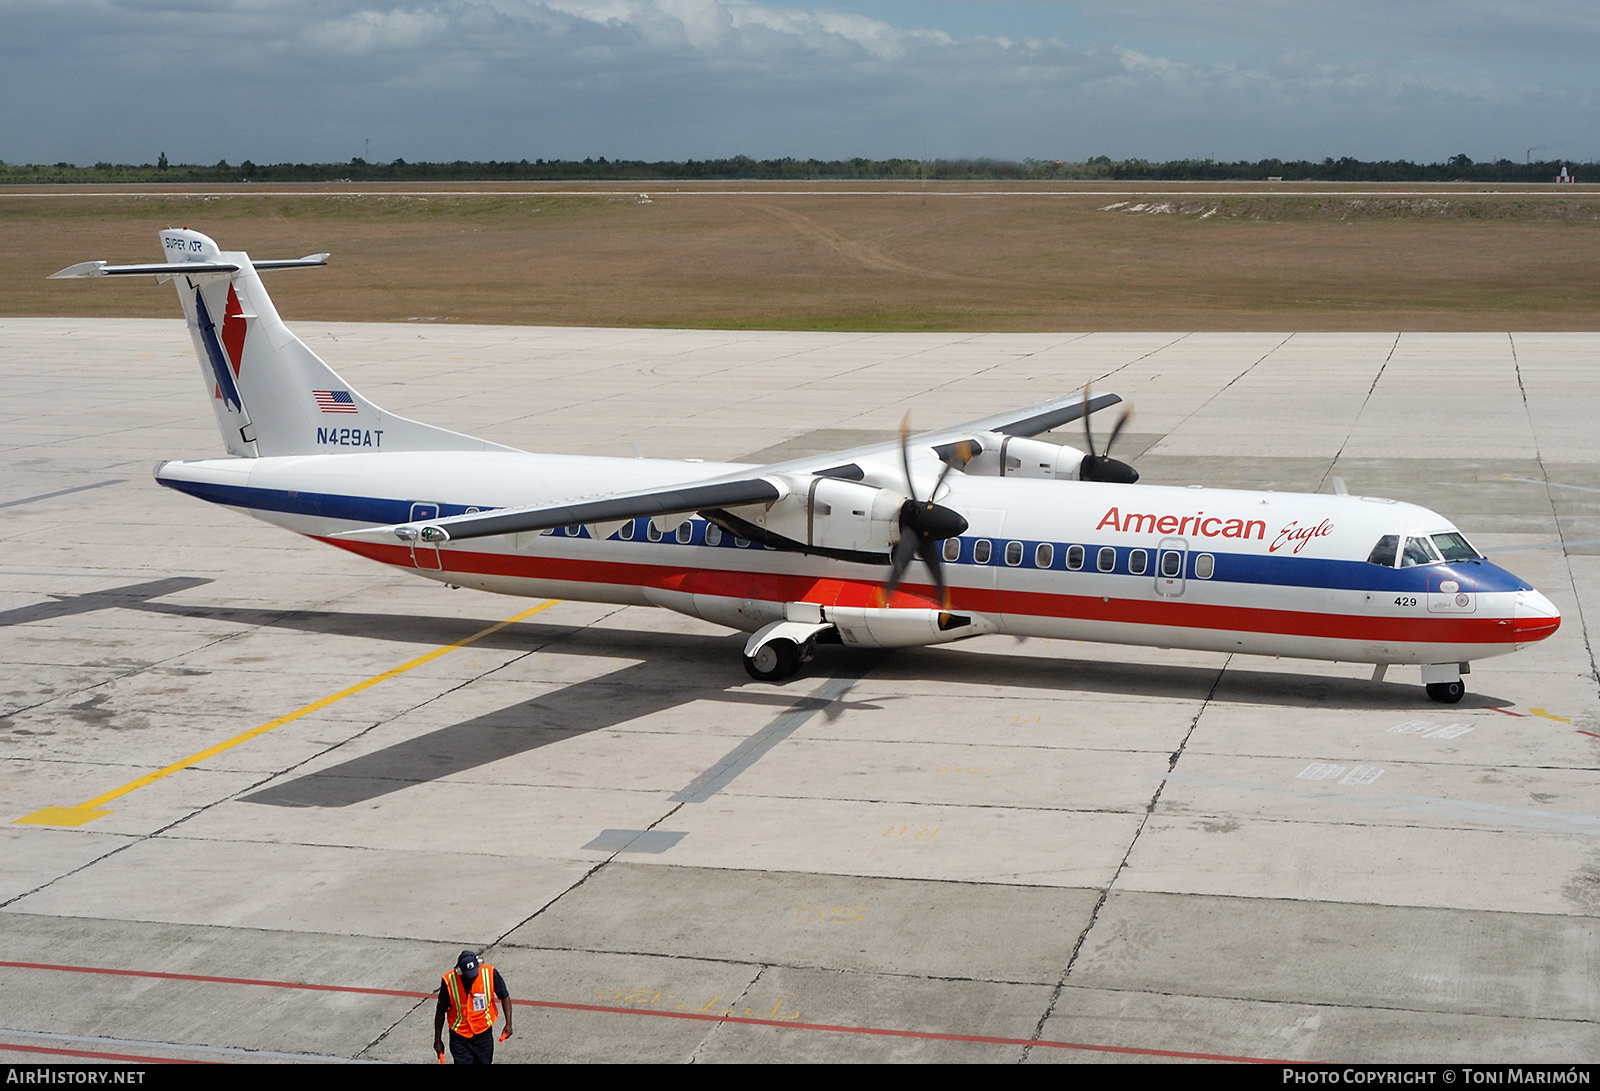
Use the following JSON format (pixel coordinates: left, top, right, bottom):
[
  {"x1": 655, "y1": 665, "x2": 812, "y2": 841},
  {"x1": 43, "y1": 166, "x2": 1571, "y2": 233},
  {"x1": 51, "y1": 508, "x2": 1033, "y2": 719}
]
[{"x1": 51, "y1": 229, "x2": 512, "y2": 458}]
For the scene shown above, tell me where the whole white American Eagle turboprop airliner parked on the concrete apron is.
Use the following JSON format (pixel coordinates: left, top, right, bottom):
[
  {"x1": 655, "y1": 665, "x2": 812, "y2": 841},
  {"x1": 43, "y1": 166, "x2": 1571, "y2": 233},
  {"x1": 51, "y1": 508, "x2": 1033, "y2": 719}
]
[{"x1": 54, "y1": 229, "x2": 1562, "y2": 702}]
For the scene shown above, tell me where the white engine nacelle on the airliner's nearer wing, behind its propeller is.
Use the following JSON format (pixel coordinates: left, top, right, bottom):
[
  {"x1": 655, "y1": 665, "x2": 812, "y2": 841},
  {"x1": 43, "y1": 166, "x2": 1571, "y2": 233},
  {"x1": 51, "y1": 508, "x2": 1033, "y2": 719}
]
[{"x1": 728, "y1": 477, "x2": 906, "y2": 553}]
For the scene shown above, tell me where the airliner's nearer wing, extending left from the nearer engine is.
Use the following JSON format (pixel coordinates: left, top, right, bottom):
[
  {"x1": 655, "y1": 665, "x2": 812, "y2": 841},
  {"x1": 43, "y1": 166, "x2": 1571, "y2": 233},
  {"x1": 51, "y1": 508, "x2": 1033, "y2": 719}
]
[{"x1": 336, "y1": 477, "x2": 784, "y2": 544}]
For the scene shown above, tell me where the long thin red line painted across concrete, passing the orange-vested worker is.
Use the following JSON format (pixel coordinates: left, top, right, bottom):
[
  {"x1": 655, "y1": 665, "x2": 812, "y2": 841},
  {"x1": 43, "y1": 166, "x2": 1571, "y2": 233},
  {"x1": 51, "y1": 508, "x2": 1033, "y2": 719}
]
[{"x1": 0, "y1": 961, "x2": 1294, "y2": 1064}]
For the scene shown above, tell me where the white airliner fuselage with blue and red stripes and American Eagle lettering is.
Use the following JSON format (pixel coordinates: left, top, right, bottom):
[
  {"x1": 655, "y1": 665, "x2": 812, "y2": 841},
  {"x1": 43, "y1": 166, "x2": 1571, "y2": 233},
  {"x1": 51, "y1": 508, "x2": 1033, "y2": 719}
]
[{"x1": 157, "y1": 450, "x2": 1560, "y2": 664}]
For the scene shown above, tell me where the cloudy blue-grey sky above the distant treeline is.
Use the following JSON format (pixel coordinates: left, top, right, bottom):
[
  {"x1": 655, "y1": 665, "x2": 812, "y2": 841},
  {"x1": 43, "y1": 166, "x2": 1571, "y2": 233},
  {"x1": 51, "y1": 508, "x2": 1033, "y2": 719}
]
[{"x1": 0, "y1": 0, "x2": 1600, "y2": 163}]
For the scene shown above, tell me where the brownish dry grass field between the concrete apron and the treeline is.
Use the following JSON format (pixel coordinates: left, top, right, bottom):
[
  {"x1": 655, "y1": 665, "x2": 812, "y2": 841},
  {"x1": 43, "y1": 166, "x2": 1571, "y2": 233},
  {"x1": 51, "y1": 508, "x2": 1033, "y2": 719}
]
[{"x1": 0, "y1": 182, "x2": 1600, "y2": 331}]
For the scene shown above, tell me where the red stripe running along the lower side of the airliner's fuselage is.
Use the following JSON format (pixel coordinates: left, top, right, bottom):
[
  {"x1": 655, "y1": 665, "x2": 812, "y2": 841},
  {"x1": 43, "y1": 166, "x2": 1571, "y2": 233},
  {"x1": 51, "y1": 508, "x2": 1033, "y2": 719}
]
[{"x1": 318, "y1": 534, "x2": 1562, "y2": 645}]
